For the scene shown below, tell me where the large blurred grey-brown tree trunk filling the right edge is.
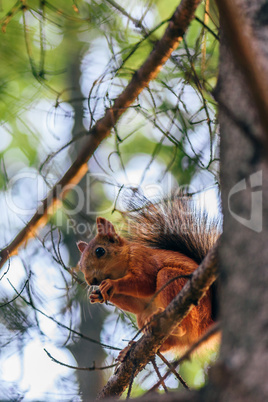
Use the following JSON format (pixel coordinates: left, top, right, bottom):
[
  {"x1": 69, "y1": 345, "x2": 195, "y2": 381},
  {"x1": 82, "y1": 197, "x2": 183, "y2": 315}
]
[{"x1": 211, "y1": 0, "x2": 268, "y2": 402}]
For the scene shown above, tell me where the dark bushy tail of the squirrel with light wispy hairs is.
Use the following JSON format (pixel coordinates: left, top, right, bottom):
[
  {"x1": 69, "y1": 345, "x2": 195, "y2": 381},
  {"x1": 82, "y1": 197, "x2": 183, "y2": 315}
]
[{"x1": 123, "y1": 194, "x2": 220, "y2": 264}]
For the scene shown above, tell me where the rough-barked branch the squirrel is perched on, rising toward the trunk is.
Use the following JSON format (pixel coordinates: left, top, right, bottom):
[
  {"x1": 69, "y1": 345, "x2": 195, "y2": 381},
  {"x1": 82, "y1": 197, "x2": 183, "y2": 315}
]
[{"x1": 98, "y1": 245, "x2": 218, "y2": 399}]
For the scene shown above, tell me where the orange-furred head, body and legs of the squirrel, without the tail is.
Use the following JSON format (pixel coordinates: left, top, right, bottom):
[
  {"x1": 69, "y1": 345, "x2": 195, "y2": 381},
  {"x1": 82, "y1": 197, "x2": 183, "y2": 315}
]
[{"x1": 78, "y1": 218, "x2": 216, "y2": 352}]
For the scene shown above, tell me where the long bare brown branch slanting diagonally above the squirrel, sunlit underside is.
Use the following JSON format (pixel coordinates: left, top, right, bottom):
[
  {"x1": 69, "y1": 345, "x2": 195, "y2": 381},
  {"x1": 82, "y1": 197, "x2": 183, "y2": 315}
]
[{"x1": 0, "y1": 0, "x2": 201, "y2": 268}]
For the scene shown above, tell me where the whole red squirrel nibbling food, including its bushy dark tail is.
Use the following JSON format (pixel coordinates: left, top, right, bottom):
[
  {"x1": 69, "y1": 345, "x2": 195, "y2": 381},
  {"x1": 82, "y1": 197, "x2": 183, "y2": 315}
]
[{"x1": 77, "y1": 196, "x2": 219, "y2": 352}]
